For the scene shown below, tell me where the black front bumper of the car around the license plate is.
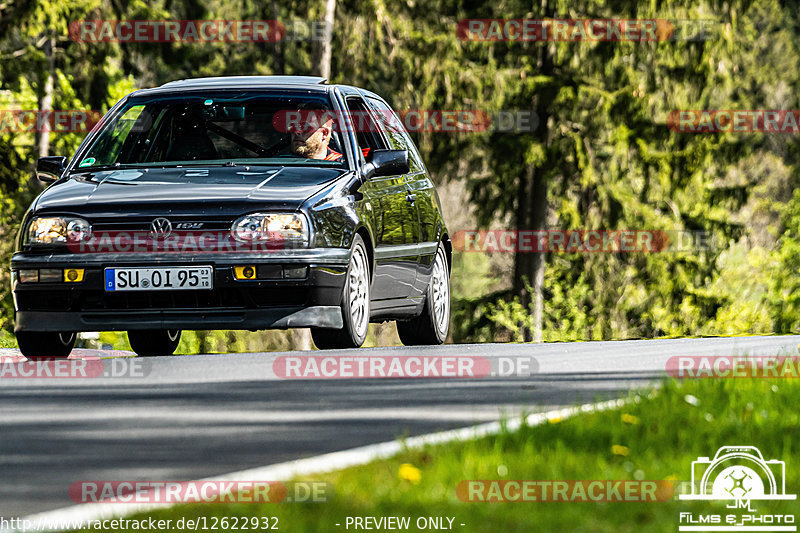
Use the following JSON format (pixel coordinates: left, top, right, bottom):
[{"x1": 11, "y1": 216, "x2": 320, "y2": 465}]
[{"x1": 11, "y1": 248, "x2": 349, "y2": 332}]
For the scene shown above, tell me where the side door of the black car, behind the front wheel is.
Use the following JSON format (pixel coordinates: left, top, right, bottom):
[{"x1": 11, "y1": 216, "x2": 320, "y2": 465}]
[{"x1": 345, "y1": 96, "x2": 419, "y2": 300}]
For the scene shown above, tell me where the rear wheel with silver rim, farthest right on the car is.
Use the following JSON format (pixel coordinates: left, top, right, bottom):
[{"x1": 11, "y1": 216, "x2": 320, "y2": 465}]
[{"x1": 397, "y1": 244, "x2": 450, "y2": 346}]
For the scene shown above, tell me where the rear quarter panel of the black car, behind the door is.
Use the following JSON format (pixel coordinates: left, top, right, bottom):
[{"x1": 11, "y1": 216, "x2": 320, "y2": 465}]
[{"x1": 367, "y1": 96, "x2": 441, "y2": 295}]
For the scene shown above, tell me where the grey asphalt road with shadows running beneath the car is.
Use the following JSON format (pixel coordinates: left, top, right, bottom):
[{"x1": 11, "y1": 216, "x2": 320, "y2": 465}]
[{"x1": 0, "y1": 337, "x2": 800, "y2": 518}]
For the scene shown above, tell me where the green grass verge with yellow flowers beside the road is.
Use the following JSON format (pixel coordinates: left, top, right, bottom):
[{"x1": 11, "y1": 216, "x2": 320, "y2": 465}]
[{"x1": 70, "y1": 379, "x2": 800, "y2": 533}]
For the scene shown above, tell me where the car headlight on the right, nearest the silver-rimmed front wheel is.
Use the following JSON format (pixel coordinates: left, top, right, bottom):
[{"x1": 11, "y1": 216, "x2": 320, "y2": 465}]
[{"x1": 231, "y1": 213, "x2": 308, "y2": 248}]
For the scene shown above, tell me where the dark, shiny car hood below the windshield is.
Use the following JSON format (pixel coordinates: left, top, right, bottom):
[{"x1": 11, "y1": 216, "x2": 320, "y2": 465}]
[{"x1": 35, "y1": 166, "x2": 347, "y2": 215}]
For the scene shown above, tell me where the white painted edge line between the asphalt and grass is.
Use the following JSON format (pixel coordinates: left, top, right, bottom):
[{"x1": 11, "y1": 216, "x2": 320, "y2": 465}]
[{"x1": 6, "y1": 399, "x2": 628, "y2": 533}]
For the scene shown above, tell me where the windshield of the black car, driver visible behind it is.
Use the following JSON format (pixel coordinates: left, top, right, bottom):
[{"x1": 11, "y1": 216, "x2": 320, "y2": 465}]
[{"x1": 75, "y1": 91, "x2": 346, "y2": 171}]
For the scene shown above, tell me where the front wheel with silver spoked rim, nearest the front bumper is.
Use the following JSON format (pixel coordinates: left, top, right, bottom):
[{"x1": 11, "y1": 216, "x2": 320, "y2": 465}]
[{"x1": 311, "y1": 234, "x2": 370, "y2": 350}]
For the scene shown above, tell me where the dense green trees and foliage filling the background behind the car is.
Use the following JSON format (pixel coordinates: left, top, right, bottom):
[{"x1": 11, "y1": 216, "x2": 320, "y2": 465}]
[{"x1": 0, "y1": 0, "x2": 800, "y2": 351}]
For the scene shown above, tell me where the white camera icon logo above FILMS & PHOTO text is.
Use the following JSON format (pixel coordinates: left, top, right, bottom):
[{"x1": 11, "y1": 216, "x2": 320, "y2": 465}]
[{"x1": 679, "y1": 446, "x2": 797, "y2": 500}]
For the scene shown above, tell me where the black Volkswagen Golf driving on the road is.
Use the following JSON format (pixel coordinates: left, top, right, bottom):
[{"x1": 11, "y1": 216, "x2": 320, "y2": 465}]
[{"x1": 11, "y1": 76, "x2": 452, "y2": 358}]
